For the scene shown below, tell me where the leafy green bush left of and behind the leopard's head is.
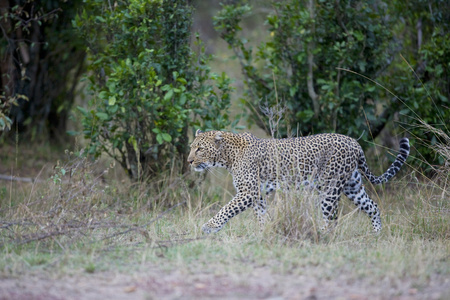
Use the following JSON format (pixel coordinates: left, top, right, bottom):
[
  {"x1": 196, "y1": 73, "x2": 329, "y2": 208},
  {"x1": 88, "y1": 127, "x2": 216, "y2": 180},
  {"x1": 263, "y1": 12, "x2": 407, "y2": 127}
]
[{"x1": 74, "y1": 0, "x2": 231, "y2": 180}]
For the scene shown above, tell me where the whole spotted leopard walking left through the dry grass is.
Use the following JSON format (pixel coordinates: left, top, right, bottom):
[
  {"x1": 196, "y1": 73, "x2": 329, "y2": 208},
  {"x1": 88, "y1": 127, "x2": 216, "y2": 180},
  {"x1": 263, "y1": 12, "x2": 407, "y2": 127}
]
[{"x1": 187, "y1": 130, "x2": 410, "y2": 234}]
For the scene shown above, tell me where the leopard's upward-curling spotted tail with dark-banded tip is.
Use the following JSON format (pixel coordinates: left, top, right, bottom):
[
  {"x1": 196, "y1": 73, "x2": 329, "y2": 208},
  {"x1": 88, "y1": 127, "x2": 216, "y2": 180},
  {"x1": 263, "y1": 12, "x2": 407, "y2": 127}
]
[{"x1": 358, "y1": 138, "x2": 410, "y2": 184}]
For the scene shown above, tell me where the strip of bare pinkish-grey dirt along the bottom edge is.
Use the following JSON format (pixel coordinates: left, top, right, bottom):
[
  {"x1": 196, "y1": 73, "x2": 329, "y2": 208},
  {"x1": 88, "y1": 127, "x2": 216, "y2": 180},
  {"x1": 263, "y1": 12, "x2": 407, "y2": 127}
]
[{"x1": 0, "y1": 265, "x2": 450, "y2": 300}]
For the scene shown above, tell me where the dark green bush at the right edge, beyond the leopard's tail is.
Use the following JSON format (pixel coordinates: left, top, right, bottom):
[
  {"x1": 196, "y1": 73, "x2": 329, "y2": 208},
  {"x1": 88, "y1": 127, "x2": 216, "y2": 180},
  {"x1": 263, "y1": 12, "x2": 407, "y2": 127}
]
[{"x1": 393, "y1": 14, "x2": 450, "y2": 169}]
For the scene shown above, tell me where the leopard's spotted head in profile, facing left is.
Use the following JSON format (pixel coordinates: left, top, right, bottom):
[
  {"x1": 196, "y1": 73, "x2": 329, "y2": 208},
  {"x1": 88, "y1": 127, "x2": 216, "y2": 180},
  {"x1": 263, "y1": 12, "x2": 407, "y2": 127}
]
[{"x1": 188, "y1": 130, "x2": 225, "y2": 172}]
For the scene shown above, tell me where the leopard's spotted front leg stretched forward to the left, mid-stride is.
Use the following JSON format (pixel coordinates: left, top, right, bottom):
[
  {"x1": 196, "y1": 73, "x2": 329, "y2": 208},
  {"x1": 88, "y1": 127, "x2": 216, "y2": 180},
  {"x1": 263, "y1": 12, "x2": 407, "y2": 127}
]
[{"x1": 202, "y1": 192, "x2": 257, "y2": 234}]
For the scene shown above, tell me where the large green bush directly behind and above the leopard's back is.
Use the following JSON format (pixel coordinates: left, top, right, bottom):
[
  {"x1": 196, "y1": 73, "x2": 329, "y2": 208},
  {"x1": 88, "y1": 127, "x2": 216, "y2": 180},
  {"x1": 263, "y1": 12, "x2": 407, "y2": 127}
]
[{"x1": 215, "y1": 1, "x2": 393, "y2": 137}]
